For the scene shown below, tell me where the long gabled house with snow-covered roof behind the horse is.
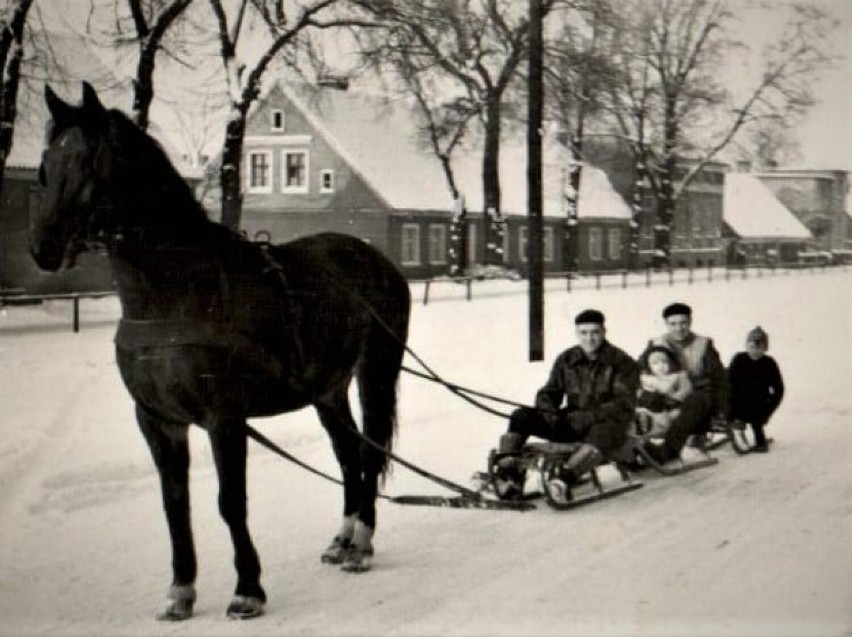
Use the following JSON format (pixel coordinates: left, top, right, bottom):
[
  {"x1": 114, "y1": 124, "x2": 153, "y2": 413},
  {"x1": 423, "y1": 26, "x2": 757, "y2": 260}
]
[{"x1": 226, "y1": 84, "x2": 629, "y2": 278}]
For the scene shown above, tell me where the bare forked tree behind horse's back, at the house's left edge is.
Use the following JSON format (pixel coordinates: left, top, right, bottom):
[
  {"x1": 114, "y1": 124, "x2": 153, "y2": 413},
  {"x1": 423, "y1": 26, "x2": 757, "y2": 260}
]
[{"x1": 210, "y1": 0, "x2": 372, "y2": 229}]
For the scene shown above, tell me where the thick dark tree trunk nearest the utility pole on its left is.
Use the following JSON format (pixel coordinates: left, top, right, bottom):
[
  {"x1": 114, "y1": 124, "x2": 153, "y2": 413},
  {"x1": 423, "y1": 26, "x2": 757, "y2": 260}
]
[{"x1": 482, "y1": 95, "x2": 504, "y2": 265}]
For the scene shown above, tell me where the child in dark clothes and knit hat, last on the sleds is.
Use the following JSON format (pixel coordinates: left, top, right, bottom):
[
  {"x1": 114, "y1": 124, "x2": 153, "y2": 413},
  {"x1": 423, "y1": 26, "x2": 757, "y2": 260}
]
[{"x1": 728, "y1": 326, "x2": 784, "y2": 453}]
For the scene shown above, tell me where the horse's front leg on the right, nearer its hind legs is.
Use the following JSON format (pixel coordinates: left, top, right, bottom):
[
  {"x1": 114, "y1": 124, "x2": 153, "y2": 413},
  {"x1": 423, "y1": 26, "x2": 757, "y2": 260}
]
[{"x1": 207, "y1": 420, "x2": 266, "y2": 619}]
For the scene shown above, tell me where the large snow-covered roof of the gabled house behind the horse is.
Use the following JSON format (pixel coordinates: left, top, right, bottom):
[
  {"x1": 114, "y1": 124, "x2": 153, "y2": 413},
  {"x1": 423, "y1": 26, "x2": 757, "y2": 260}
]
[{"x1": 281, "y1": 86, "x2": 630, "y2": 219}]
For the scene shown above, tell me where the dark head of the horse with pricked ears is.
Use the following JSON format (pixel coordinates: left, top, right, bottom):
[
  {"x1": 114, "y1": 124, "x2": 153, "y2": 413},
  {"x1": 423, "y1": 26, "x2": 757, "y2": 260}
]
[{"x1": 30, "y1": 83, "x2": 109, "y2": 272}]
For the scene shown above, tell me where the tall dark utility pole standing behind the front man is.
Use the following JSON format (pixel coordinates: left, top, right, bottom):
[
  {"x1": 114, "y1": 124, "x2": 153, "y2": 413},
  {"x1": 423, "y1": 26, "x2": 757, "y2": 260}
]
[{"x1": 527, "y1": 0, "x2": 544, "y2": 361}]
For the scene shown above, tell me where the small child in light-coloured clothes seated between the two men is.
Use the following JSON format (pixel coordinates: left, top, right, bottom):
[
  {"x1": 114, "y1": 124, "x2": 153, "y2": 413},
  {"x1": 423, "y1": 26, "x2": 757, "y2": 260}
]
[{"x1": 636, "y1": 346, "x2": 692, "y2": 436}]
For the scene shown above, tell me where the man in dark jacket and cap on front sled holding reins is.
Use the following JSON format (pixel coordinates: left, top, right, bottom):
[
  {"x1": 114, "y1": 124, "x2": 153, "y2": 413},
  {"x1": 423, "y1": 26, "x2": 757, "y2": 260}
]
[{"x1": 498, "y1": 310, "x2": 639, "y2": 498}]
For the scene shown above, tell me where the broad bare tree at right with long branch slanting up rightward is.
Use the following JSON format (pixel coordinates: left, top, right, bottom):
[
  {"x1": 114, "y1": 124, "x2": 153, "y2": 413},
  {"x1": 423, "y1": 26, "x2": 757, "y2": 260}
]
[{"x1": 600, "y1": 0, "x2": 835, "y2": 266}]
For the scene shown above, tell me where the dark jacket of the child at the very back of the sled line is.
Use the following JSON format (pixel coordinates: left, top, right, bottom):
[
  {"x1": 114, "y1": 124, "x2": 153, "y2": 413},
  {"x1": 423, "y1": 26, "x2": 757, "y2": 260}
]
[{"x1": 728, "y1": 352, "x2": 784, "y2": 425}]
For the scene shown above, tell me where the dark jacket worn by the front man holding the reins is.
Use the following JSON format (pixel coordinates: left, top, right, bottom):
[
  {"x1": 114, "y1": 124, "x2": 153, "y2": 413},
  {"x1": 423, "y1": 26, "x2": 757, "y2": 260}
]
[{"x1": 535, "y1": 341, "x2": 639, "y2": 427}]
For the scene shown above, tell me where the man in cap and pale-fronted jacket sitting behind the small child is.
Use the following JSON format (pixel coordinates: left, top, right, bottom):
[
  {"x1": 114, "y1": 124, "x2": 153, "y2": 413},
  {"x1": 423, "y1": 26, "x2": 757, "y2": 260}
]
[{"x1": 639, "y1": 303, "x2": 728, "y2": 462}]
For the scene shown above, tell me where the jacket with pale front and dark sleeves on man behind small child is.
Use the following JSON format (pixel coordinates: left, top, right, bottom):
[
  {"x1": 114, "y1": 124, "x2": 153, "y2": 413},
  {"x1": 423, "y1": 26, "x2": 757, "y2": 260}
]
[{"x1": 639, "y1": 334, "x2": 728, "y2": 416}]
